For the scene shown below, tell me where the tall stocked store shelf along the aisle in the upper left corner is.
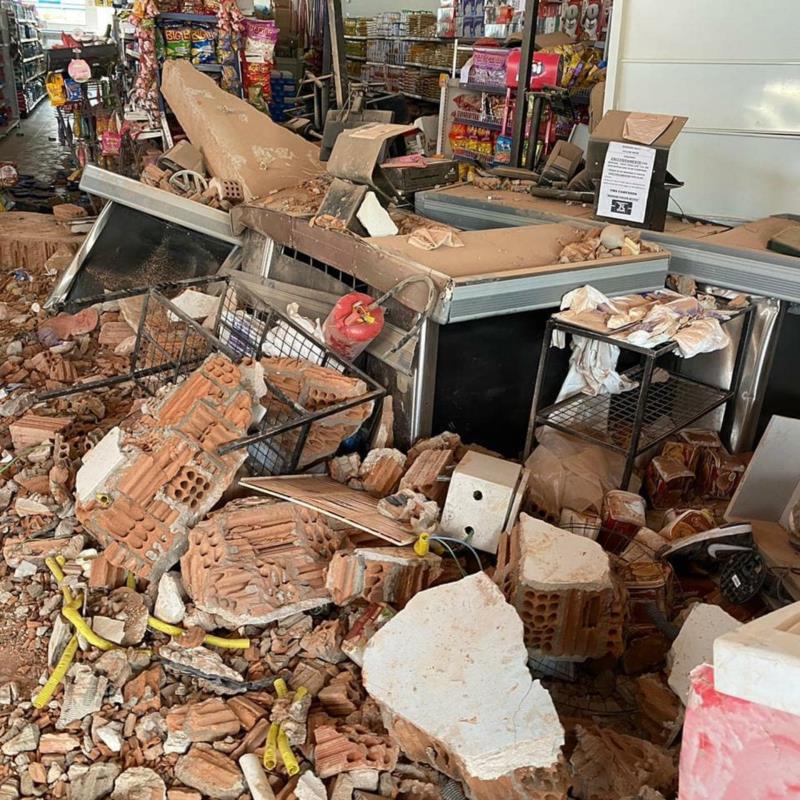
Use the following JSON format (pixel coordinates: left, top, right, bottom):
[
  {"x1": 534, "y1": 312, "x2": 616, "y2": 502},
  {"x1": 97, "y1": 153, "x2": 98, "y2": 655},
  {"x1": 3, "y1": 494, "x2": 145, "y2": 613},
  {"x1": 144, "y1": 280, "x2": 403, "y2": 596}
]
[{"x1": 5, "y1": 2, "x2": 47, "y2": 117}]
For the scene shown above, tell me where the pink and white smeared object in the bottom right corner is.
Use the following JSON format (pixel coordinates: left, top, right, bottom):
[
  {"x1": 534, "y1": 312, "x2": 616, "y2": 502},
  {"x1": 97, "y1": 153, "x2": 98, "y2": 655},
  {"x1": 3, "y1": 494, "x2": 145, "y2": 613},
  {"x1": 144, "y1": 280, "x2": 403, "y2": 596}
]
[{"x1": 678, "y1": 664, "x2": 800, "y2": 800}]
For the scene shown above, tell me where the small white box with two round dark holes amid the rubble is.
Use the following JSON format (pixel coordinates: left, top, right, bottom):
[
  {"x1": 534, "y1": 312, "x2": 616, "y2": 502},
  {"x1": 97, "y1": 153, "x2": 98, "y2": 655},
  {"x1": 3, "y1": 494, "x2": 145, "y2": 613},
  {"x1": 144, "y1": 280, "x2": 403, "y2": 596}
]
[{"x1": 440, "y1": 450, "x2": 522, "y2": 553}]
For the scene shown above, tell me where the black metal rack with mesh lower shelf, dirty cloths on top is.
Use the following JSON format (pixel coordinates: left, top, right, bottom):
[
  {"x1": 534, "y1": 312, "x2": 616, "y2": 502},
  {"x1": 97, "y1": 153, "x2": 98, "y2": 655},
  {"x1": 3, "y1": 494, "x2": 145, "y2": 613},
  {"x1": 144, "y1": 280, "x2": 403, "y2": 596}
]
[{"x1": 525, "y1": 306, "x2": 753, "y2": 488}]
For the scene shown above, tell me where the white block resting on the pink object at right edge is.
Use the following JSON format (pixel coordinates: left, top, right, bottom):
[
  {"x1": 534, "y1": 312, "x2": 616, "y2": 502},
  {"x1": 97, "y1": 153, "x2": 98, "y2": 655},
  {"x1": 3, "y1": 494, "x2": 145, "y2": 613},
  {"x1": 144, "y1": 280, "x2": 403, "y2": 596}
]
[{"x1": 714, "y1": 603, "x2": 800, "y2": 715}]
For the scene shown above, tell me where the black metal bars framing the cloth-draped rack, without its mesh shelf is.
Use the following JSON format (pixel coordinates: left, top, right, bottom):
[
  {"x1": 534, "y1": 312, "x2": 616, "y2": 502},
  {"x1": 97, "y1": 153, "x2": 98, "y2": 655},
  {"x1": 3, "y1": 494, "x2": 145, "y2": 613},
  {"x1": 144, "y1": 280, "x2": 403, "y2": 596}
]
[{"x1": 524, "y1": 306, "x2": 753, "y2": 488}]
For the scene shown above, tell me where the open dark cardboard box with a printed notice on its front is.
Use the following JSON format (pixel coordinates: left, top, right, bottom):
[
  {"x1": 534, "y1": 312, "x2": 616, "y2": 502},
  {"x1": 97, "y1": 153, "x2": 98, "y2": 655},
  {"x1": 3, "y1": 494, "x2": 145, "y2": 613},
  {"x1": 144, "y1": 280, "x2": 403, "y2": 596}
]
[{"x1": 586, "y1": 111, "x2": 688, "y2": 231}]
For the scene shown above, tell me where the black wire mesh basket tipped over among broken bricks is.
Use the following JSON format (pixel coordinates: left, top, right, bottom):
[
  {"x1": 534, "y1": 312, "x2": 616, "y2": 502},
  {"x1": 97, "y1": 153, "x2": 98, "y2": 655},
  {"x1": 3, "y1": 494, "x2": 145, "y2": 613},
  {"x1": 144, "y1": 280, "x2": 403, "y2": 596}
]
[{"x1": 40, "y1": 277, "x2": 385, "y2": 475}]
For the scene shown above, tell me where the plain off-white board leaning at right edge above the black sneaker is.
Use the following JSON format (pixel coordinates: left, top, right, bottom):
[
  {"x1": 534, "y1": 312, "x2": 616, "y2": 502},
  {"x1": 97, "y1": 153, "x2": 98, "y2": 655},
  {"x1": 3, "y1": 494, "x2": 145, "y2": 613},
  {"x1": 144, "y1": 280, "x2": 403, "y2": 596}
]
[{"x1": 725, "y1": 415, "x2": 800, "y2": 522}]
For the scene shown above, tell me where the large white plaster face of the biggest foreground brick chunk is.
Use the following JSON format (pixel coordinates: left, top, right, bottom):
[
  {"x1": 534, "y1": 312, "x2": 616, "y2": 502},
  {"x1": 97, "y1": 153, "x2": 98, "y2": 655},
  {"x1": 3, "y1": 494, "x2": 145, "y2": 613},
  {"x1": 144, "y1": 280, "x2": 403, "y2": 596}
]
[{"x1": 364, "y1": 576, "x2": 564, "y2": 780}]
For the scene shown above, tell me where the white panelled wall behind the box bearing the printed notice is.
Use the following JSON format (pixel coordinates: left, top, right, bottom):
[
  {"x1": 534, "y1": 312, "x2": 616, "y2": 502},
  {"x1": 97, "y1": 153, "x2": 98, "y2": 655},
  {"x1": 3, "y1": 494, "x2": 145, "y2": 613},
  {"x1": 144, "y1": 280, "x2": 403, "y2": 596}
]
[{"x1": 605, "y1": 0, "x2": 800, "y2": 219}]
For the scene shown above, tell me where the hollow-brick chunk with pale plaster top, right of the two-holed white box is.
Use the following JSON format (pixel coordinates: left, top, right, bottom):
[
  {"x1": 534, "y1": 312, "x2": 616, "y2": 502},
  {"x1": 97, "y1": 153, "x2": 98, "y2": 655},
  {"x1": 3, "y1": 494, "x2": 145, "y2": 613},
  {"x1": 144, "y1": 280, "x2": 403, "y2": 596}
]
[{"x1": 495, "y1": 514, "x2": 625, "y2": 661}]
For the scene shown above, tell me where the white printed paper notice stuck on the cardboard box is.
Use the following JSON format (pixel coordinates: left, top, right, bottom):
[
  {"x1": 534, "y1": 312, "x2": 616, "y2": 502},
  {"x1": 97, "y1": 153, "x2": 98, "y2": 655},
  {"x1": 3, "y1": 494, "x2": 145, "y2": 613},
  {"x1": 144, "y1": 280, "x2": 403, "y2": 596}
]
[{"x1": 597, "y1": 142, "x2": 656, "y2": 222}]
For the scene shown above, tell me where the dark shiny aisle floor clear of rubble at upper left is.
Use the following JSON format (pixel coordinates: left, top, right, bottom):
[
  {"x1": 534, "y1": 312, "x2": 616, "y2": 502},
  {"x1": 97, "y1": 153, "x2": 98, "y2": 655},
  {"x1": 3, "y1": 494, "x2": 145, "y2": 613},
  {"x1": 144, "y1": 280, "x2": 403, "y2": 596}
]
[{"x1": 0, "y1": 102, "x2": 70, "y2": 183}]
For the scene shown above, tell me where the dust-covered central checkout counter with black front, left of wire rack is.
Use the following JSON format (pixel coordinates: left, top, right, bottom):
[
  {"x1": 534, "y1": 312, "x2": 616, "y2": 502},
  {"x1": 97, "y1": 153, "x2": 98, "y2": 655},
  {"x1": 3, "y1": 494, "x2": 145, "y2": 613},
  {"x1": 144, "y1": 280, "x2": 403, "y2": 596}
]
[{"x1": 232, "y1": 204, "x2": 669, "y2": 456}]
